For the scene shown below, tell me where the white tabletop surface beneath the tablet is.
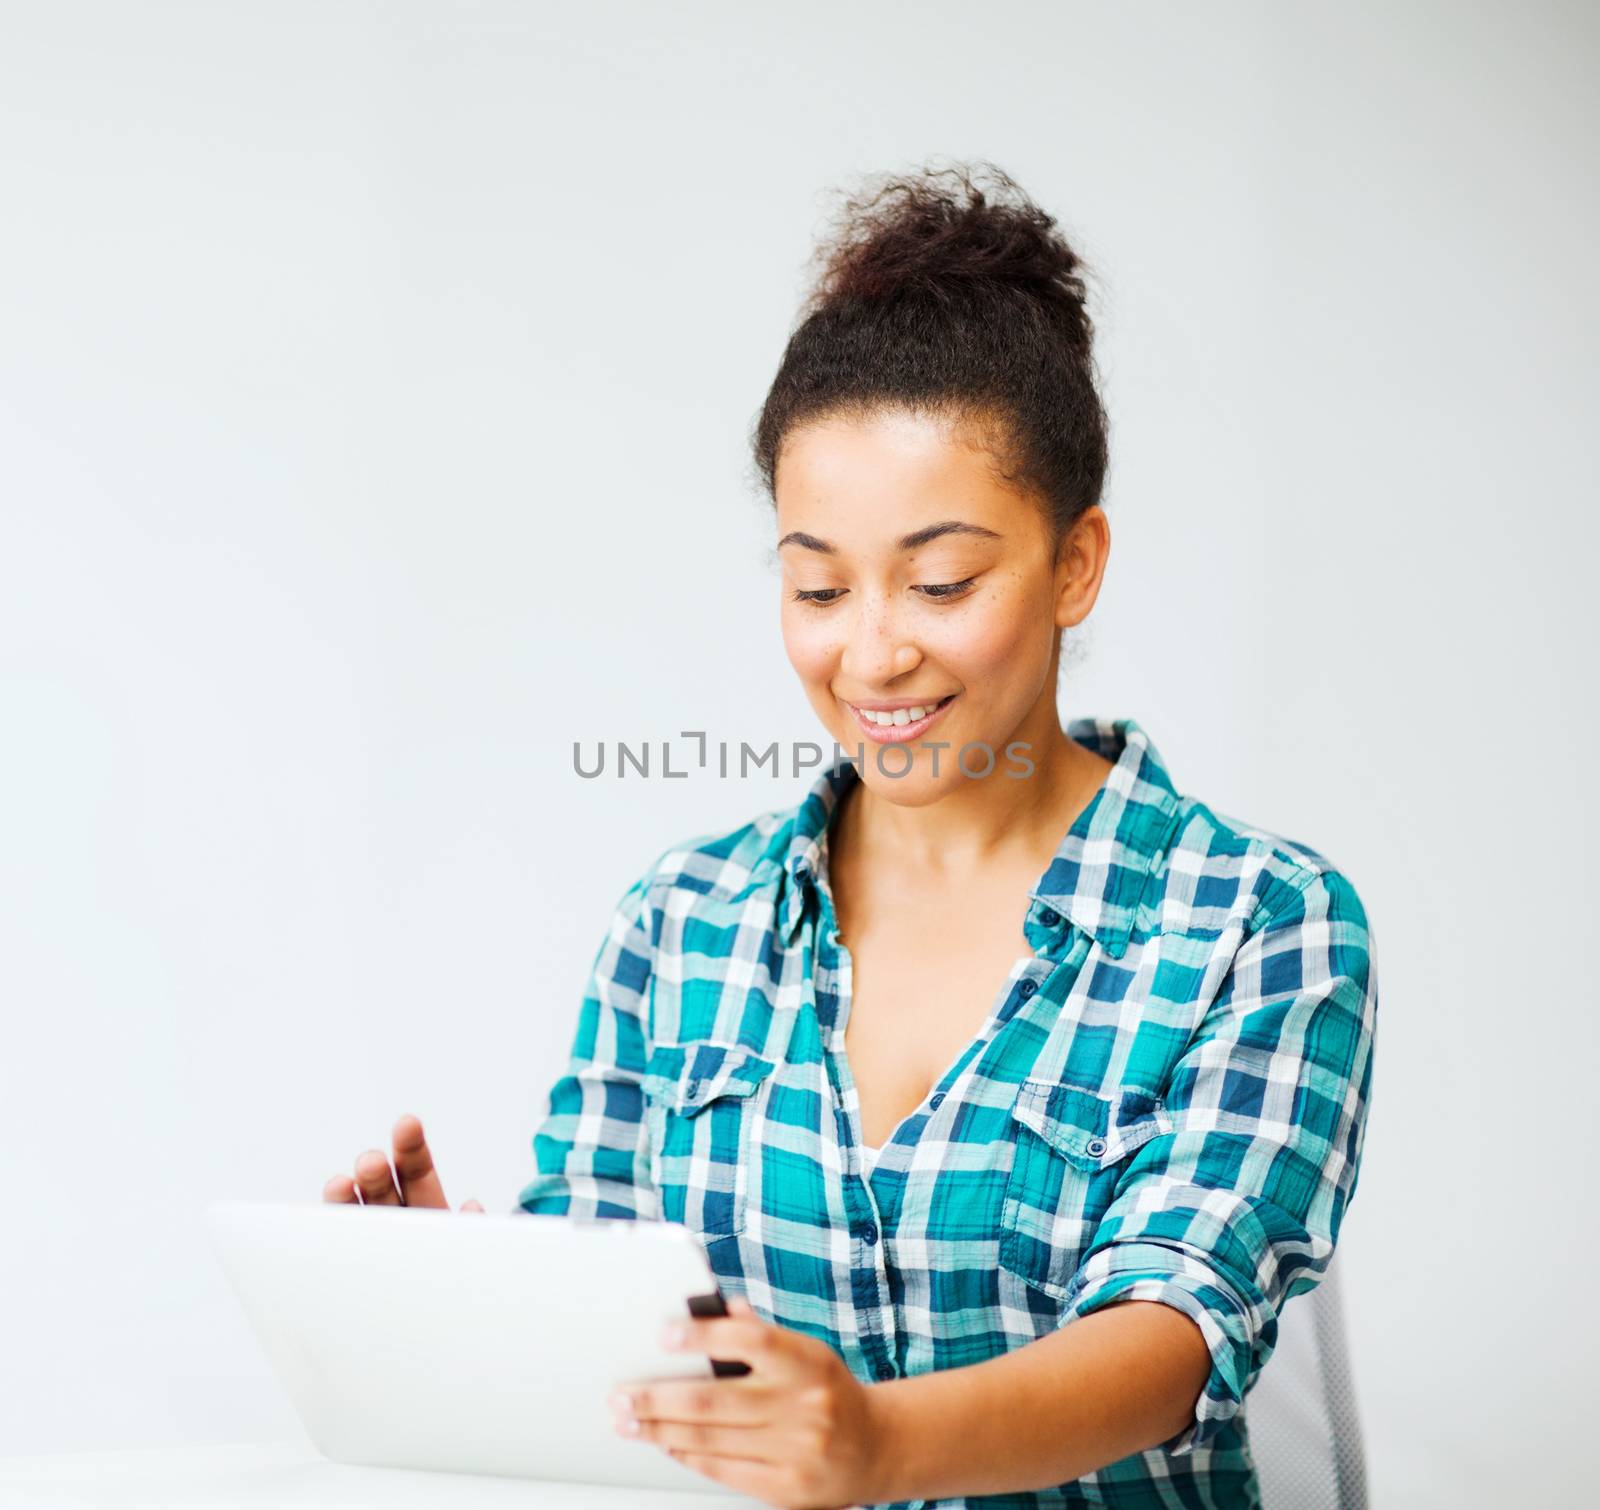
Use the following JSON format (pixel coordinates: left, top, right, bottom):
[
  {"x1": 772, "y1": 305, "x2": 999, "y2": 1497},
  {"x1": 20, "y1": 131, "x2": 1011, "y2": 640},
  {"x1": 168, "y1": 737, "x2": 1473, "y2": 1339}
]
[{"x1": 0, "y1": 1441, "x2": 774, "y2": 1510}]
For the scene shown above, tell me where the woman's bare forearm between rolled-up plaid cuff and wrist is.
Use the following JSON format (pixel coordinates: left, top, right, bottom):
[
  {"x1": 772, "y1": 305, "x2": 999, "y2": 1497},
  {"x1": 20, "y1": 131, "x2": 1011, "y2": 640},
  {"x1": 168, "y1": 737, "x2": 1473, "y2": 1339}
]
[{"x1": 869, "y1": 1300, "x2": 1211, "y2": 1502}]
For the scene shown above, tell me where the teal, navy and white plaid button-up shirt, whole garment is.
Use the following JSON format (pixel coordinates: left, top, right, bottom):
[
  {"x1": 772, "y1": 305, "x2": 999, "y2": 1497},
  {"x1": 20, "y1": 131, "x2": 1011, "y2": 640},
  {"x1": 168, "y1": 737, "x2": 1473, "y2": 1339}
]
[{"x1": 518, "y1": 720, "x2": 1378, "y2": 1510}]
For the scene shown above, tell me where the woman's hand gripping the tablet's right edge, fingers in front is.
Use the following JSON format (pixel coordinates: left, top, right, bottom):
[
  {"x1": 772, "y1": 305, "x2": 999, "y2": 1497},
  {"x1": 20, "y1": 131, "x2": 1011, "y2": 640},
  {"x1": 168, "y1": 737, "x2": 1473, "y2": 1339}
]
[{"x1": 611, "y1": 1299, "x2": 886, "y2": 1510}]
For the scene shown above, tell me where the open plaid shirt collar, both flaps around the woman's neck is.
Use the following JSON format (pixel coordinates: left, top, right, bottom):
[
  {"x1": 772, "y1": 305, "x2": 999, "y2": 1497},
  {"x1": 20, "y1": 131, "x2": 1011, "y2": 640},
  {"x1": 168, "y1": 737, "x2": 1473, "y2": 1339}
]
[{"x1": 779, "y1": 718, "x2": 1181, "y2": 960}]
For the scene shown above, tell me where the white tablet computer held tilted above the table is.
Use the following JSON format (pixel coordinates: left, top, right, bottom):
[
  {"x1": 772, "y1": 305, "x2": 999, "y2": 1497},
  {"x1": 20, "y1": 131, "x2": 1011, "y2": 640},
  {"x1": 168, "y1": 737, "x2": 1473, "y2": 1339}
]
[{"x1": 208, "y1": 1201, "x2": 755, "y2": 1504}]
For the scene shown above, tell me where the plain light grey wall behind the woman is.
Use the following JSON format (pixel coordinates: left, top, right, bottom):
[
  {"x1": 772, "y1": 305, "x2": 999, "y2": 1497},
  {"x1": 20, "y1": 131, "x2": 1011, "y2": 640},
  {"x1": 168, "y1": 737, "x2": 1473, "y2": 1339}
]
[{"x1": 0, "y1": 0, "x2": 1597, "y2": 1507}]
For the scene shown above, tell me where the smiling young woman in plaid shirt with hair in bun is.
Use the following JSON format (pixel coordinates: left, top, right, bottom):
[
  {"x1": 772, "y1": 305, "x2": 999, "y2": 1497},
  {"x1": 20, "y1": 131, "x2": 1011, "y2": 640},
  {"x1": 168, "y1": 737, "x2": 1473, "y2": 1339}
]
[{"x1": 325, "y1": 170, "x2": 1376, "y2": 1507}]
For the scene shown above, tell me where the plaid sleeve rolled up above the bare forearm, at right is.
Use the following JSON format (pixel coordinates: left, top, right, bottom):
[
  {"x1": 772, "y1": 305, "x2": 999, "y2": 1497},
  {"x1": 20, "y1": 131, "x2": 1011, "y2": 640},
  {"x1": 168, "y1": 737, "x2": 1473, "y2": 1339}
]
[{"x1": 1061, "y1": 870, "x2": 1378, "y2": 1454}]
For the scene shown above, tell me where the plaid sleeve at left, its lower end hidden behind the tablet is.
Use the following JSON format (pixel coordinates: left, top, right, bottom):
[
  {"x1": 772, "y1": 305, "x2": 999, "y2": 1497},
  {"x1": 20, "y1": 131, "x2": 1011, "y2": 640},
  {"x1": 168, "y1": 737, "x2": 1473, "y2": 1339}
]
[{"x1": 517, "y1": 867, "x2": 659, "y2": 1219}]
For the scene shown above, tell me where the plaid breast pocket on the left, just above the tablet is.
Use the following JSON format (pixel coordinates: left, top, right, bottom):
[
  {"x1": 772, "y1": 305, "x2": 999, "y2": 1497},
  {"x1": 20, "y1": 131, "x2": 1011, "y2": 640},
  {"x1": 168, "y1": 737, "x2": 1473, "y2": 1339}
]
[{"x1": 643, "y1": 1040, "x2": 774, "y2": 1238}]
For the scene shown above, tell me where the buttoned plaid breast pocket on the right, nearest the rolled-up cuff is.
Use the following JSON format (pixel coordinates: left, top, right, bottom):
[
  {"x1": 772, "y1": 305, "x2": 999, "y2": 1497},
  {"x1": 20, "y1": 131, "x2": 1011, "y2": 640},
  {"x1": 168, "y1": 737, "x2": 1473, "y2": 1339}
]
[{"x1": 1000, "y1": 1080, "x2": 1173, "y2": 1300}]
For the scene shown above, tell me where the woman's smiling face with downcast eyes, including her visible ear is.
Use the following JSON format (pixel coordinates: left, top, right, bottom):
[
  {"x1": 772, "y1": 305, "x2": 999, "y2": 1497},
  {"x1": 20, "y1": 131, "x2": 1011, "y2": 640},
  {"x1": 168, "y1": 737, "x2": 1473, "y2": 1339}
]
[{"x1": 774, "y1": 401, "x2": 1109, "y2": 805}]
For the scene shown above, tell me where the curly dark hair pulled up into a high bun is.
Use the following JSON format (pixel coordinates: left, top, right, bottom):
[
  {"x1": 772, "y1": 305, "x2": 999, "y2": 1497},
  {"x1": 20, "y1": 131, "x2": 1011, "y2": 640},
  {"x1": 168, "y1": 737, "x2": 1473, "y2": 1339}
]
[{"x1": 750, "y1": 162, "x2": 1107, "y2": 544}]
